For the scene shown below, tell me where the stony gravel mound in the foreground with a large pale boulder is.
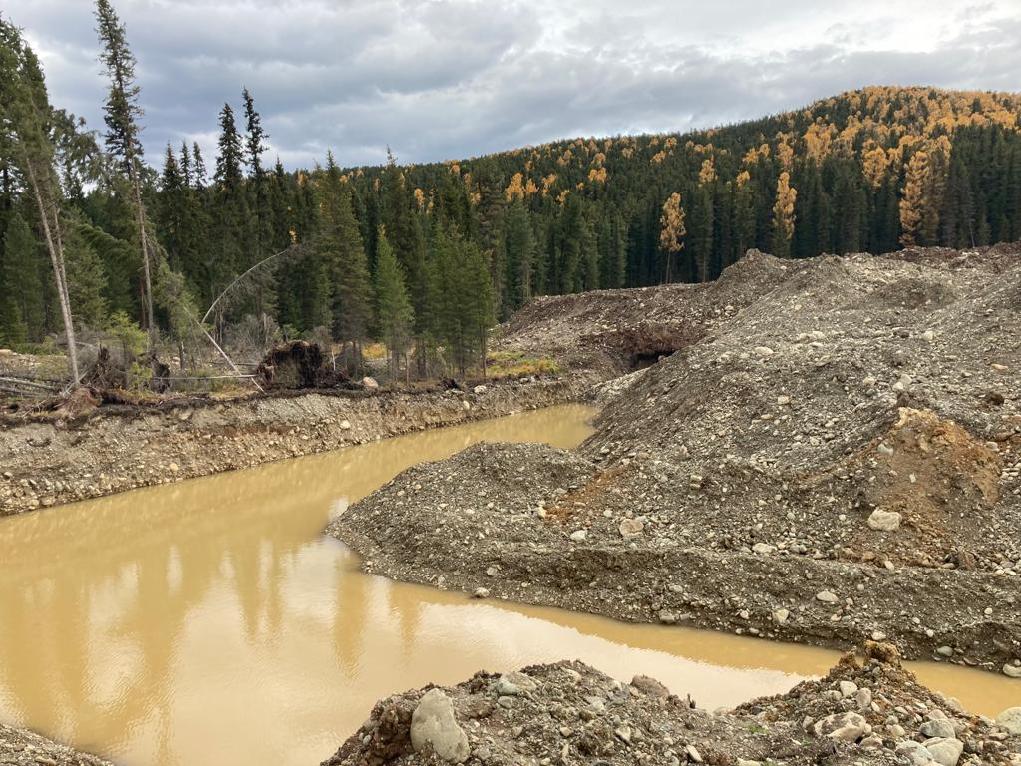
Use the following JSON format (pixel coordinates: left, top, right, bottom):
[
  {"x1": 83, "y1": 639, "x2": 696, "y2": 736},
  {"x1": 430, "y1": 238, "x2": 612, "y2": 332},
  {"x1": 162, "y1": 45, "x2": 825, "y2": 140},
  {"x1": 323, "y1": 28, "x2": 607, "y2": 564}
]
[{"x1": 323, "y1": 642, "x2": 1021, "y2": 766}]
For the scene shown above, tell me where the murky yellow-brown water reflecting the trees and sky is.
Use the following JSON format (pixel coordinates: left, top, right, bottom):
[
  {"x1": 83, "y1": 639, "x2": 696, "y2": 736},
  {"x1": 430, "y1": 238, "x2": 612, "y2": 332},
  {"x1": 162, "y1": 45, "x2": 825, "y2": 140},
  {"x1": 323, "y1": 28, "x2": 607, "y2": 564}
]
[{"x1": 0, "y1": 406, "x2": 1018, "y2": 766}]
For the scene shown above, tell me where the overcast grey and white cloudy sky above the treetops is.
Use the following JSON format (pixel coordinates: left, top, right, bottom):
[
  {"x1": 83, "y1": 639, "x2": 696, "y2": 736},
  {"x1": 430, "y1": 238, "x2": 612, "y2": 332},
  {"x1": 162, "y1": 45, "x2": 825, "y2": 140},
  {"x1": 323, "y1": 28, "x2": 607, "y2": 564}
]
[{"x1": 3, "y1": 0, "x2": 1021, "y2": 167}]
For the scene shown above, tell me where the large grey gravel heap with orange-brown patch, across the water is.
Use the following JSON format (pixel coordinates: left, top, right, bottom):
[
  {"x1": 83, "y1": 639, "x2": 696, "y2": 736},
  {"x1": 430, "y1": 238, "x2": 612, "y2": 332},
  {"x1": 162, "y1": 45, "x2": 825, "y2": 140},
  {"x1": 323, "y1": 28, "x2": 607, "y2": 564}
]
[{"x1": 330, "y1": 246, "x2": 1021, "y2": 674}]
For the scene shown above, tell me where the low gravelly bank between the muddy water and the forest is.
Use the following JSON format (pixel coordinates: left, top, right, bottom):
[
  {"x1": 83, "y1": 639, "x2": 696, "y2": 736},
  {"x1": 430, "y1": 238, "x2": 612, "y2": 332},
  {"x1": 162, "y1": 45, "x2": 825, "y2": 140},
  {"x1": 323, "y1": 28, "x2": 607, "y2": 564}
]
[{"x1": 0, "y1": 371, "x2": 601, "y2": 516}]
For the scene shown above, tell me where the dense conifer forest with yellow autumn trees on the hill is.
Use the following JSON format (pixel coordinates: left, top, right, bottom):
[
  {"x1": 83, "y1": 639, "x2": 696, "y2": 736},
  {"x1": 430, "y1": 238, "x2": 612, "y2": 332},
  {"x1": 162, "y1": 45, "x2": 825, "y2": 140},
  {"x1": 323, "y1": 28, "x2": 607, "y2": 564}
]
[{"x1": 0, "y1": 0, "x2": 1021, "y2": 384}]
